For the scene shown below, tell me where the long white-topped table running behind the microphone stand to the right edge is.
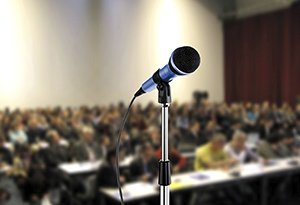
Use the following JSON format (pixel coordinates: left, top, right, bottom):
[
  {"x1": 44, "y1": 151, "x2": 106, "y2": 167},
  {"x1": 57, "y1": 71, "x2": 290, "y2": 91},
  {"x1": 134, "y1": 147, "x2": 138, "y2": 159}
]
[{"x1": 100, "y1": 159, "x2": 300, "y2": 205}]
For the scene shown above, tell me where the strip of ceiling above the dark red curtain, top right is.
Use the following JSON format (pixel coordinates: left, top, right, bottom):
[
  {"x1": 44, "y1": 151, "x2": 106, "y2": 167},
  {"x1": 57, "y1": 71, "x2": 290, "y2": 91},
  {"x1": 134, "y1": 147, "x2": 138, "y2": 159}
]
[{"x1": 199, "y1": 0, "x2": 300, "y2": 19}]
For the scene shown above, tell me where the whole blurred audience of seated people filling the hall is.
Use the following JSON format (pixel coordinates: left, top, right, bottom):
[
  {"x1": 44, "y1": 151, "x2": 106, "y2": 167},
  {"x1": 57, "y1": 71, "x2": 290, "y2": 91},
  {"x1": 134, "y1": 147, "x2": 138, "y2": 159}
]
[{"x1": 0, "y1": 99, "x2": 300, "y2": 205}]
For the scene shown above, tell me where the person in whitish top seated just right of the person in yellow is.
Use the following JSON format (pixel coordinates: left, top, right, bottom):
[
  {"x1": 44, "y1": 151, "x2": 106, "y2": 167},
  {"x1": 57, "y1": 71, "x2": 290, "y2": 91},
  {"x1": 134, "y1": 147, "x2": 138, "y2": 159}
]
[{"x1": 225, "y1": 130, "x2": 259, "y2": 164}]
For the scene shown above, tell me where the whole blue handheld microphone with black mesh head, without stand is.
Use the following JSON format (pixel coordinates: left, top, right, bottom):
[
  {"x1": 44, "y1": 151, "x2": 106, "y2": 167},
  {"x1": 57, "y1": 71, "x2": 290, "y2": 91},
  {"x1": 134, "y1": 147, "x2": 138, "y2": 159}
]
[{"x1": 134, "y1": 46, "x2": 200, "y2": 97}]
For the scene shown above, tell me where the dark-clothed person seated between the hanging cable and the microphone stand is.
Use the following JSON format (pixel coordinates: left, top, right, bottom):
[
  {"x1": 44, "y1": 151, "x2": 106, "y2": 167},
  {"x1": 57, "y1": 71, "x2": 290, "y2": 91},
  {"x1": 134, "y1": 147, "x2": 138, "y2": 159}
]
[{"x1": 129, "y1": 142, "x2": 159, "y2": 182}]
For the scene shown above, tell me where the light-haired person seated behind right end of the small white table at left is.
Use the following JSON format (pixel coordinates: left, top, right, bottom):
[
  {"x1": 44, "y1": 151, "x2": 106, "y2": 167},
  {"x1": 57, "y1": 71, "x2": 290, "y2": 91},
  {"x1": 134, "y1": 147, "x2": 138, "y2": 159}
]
[{"x1": 72, "y1": 127, "x2": 102, "y2": 162}]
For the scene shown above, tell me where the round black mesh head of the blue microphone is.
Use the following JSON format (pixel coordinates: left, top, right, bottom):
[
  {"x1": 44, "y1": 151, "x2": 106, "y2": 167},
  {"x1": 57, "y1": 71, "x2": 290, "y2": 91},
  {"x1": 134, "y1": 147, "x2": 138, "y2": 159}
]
[{"x1": 170, "y1": 46, "x2": 200, "y2": 75}]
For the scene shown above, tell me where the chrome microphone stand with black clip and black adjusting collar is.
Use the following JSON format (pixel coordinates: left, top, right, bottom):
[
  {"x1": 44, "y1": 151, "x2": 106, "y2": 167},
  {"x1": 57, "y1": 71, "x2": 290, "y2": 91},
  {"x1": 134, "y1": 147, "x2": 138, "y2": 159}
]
[{"x1": 157, "y1": 81, "x2": 171, "y2": 205}]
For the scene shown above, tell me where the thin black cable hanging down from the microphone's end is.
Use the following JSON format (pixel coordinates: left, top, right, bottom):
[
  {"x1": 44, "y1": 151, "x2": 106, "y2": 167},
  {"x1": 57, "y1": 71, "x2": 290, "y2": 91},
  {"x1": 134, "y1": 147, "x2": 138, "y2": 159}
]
[{"x1": 116, "y1": 96, "x2": 136, "y2": 205}]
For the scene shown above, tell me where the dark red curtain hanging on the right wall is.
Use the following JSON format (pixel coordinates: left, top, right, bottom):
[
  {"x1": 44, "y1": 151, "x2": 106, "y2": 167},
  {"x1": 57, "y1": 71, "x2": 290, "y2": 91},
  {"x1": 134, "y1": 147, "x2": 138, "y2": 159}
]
[{"x1": 224, "y1": 4, "x2": 300, "y2": 104}]
